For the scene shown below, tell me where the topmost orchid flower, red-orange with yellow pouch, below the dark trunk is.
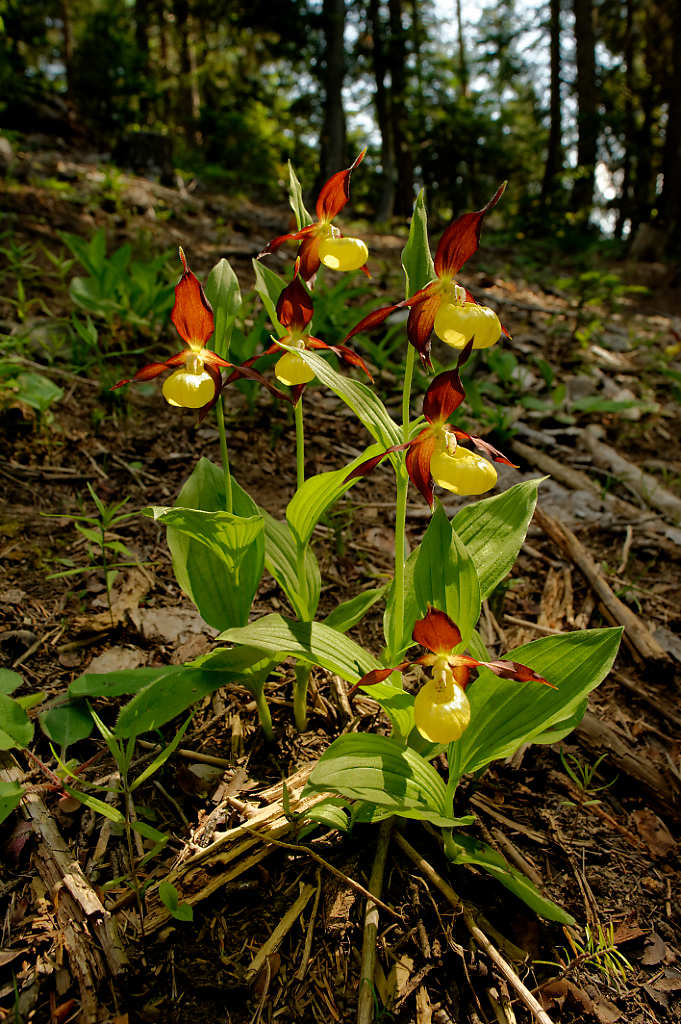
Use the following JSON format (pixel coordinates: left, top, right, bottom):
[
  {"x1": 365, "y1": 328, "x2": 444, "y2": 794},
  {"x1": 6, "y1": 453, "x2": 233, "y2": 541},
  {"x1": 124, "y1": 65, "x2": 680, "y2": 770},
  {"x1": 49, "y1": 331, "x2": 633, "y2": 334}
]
[{"x1": 258, "y1": 150, "x2": 369, "y2": 281}]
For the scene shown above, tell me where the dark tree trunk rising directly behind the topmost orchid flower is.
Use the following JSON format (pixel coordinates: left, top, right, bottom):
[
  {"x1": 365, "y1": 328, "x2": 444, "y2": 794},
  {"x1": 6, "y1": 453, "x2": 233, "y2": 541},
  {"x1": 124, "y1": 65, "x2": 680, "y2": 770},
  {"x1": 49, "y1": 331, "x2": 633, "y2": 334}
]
[{"x1": 320, "y1": 0, "x2": 346, "y2": 181}]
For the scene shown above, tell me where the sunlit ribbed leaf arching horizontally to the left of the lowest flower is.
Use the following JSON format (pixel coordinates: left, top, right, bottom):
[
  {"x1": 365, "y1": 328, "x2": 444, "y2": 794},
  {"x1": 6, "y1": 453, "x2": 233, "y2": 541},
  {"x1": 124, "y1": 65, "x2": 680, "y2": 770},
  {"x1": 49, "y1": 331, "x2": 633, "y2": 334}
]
[{"x1": 223, "y1": 614, "x2": 380, "y2": 683}]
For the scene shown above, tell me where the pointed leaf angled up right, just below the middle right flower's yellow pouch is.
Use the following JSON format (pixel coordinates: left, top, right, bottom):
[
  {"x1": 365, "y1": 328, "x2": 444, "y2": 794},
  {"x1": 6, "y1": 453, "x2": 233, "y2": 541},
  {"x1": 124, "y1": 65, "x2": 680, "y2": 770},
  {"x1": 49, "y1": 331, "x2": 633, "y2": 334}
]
[{"x1": 452, "y1": 477, "x2": 546, "y2": 600}]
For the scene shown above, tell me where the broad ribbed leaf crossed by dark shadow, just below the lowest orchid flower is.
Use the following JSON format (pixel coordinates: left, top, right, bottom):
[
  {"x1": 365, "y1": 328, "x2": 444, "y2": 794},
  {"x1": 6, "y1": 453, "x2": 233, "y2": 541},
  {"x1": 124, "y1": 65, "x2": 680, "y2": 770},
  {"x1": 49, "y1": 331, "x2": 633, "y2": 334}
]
[{"x1": 303, "y1": 732, "x2": 452, "y2": 825}]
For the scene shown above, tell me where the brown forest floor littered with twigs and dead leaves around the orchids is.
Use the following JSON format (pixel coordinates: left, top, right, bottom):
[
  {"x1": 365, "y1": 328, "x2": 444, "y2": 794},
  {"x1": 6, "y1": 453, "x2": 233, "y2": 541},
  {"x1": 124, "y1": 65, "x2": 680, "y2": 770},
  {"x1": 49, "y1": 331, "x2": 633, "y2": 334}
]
[{"x1": 0, "y1": 140, "x2": 681, "y2": 1024}]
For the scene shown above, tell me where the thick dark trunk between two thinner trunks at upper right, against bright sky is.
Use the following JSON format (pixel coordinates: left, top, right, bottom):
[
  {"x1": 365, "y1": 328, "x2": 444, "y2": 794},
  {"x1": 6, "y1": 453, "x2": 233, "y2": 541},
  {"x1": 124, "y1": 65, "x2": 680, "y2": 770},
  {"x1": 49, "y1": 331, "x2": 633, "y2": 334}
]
[{"x1": 571, "y1": 0, "x2": 599, "y2": 222}]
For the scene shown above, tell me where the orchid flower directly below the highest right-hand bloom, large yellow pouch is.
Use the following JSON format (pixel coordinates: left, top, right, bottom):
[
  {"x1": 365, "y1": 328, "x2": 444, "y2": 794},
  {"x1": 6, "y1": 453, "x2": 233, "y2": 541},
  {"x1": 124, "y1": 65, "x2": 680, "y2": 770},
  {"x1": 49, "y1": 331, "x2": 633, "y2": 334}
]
[{"x1": 348, "y1": 341, "x2": 515, "y2": 508}]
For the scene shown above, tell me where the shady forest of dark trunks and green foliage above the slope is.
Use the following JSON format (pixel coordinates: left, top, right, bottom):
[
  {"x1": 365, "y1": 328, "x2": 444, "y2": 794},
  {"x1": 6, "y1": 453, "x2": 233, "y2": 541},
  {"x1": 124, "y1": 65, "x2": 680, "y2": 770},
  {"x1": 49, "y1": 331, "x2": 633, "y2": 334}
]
[{"x1": 0, "y1": 0, "x2": 681, "y2": 259}]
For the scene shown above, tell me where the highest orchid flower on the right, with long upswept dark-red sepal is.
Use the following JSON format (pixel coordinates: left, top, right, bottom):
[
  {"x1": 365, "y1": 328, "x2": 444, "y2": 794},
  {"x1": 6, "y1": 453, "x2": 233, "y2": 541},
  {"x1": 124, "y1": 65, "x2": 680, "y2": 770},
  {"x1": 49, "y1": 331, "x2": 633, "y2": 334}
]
[{"x1": 345, "y1": 182, "x2": 508, "y2": 369}]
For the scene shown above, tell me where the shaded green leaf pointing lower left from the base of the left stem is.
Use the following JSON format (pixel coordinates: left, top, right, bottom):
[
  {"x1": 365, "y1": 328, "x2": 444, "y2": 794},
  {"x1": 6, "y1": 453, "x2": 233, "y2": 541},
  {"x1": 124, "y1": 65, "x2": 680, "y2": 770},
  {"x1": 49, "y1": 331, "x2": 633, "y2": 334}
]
[{"x1": 115, "y1": 647, "x2": 270, "y2": 737}]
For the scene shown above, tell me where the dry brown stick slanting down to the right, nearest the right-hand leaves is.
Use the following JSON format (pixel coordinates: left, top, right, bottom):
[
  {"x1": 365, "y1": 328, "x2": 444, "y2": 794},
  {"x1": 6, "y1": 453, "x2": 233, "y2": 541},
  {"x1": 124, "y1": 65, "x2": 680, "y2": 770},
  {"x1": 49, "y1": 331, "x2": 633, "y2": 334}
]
[{"x1": 535, "y1": 508, "x2": 669, "y2": 662}]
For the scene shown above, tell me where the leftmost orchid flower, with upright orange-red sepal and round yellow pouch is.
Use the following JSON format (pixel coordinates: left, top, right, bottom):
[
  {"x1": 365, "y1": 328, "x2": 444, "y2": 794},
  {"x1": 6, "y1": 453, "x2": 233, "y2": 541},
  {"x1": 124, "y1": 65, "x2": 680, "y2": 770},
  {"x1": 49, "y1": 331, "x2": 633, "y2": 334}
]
[{"x1": 112, "y1": 248, "x2": 233, "y2": 412}]
